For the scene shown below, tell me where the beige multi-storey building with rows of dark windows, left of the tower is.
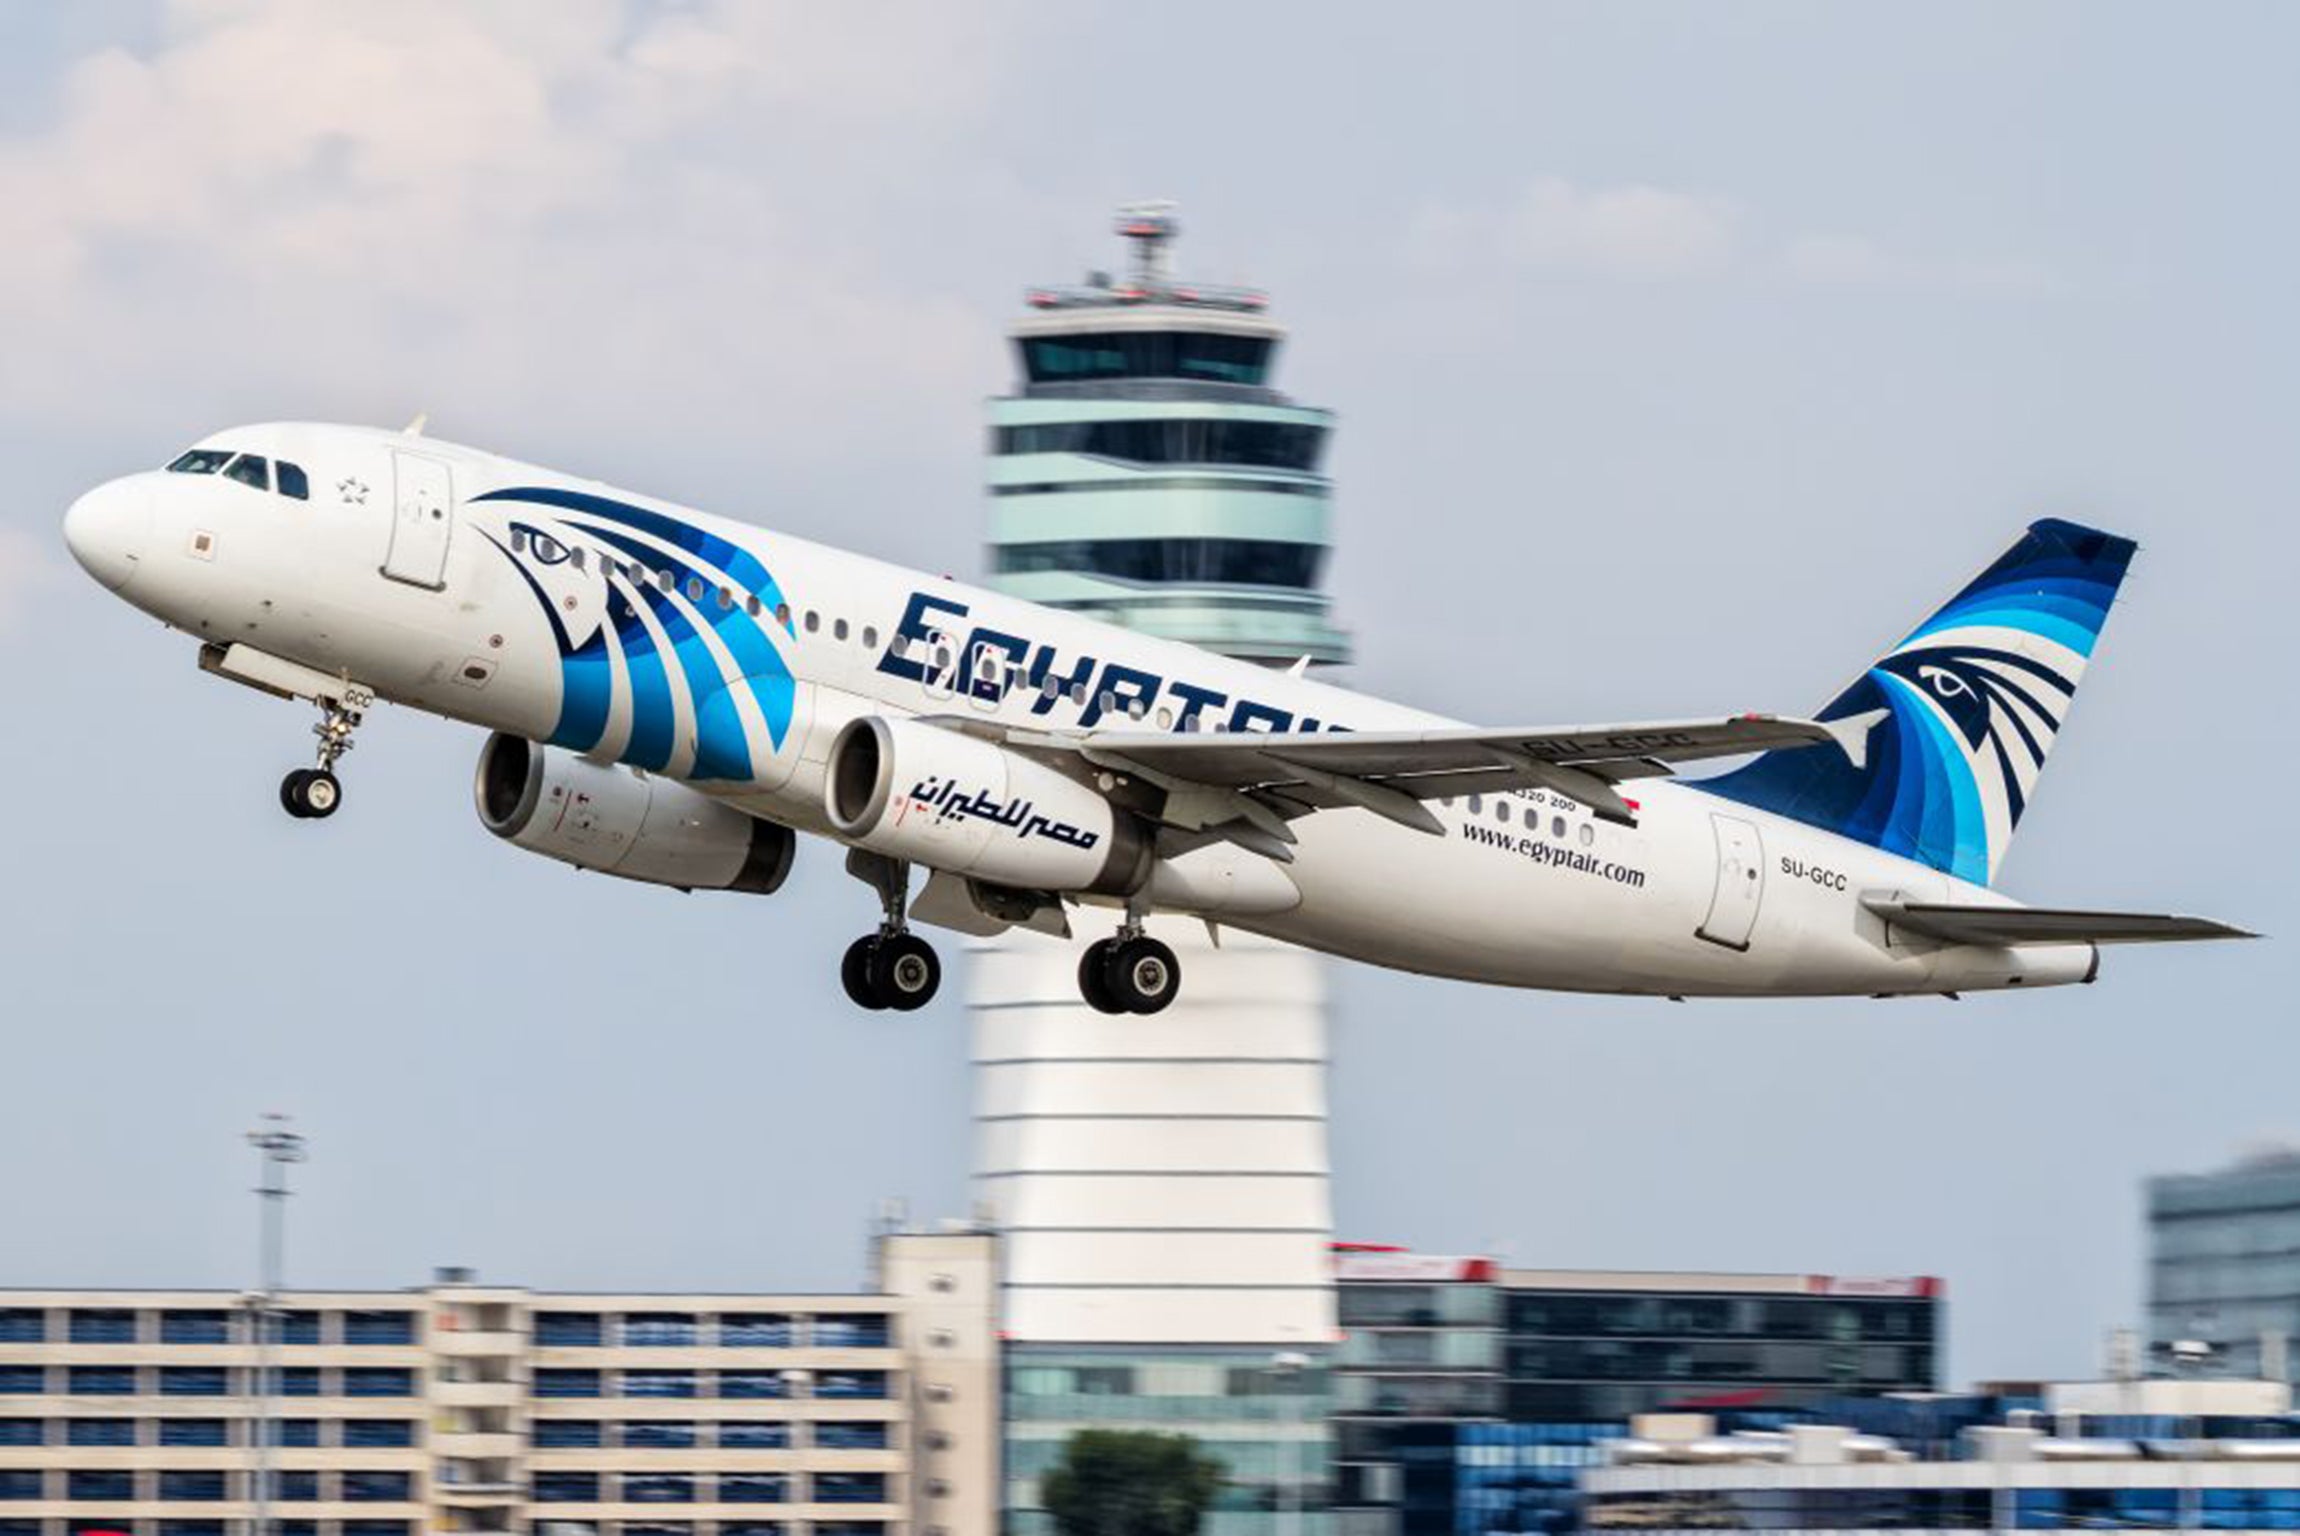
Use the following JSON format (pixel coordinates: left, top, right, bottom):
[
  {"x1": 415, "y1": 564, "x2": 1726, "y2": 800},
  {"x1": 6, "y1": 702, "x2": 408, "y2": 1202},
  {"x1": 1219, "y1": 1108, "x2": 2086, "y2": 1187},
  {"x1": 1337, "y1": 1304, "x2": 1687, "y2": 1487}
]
[{"x1": 0, "y1": 1232, "x2": 998, "y2": 1536}]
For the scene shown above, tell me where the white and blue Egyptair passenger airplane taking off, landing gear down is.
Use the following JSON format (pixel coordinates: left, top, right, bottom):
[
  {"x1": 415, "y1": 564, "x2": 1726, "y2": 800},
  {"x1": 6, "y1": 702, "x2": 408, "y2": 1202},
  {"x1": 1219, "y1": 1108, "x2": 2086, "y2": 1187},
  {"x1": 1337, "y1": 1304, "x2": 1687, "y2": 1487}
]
[{"x1": 64, "y1": 421, "x2": 2249, "y2": 1014}]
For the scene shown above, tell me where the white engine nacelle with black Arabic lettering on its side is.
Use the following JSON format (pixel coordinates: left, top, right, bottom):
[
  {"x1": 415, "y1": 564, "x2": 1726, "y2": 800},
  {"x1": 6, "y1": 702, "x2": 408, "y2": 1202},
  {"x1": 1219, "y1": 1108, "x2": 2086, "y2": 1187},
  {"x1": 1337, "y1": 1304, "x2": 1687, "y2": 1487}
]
[{"x1": 823, "y1": 715, "x2": 1150, "y2": 894}]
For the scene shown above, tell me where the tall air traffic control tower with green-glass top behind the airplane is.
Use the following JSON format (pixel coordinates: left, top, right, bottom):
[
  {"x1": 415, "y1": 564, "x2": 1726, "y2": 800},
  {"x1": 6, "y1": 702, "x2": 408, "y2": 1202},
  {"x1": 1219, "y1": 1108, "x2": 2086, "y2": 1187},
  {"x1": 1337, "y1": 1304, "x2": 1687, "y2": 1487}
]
[{"x1": 971, "y1": 205, "x2": 1348, "y2": 1536}]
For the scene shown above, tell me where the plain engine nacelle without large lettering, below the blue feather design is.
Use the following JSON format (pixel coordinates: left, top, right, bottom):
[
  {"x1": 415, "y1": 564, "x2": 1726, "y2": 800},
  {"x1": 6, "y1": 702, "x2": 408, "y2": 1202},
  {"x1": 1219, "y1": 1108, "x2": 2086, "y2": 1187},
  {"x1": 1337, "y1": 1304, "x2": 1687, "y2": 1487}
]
[{"x1": 472, "y1": 731, "x2": 798, "y2": 897}]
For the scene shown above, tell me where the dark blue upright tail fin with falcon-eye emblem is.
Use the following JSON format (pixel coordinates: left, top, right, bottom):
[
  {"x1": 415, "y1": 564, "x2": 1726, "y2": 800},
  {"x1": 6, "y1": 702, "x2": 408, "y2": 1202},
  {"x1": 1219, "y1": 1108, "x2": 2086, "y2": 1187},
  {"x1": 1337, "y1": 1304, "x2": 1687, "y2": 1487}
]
[{"x1": 1702, "y1": 517, "x2": 2137, "y2": 883}]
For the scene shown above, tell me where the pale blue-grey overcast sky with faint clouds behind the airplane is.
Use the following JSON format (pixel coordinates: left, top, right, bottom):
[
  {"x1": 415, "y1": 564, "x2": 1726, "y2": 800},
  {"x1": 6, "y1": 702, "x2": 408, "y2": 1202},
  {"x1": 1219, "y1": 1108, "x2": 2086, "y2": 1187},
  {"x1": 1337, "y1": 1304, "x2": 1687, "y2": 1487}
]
[{"x1": 0, "y1": 0, "x2": 2300, "y2": 1380}]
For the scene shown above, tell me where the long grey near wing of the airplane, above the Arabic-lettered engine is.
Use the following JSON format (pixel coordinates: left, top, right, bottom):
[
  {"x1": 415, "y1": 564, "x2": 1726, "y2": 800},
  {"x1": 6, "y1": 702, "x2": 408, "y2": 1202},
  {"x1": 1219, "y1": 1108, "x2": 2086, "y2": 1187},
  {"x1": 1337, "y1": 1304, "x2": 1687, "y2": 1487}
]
[{"x1": 1003, "y1": 715, "x2": 1870, "y2": 842}]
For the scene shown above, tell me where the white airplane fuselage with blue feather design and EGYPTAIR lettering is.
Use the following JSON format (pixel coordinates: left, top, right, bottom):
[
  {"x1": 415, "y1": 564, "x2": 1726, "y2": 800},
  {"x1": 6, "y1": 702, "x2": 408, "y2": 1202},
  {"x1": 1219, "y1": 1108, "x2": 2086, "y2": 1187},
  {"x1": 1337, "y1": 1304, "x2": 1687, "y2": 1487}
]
[{"x1": 74, "y1": 425, "x2": 2095, "y2": 996}]
